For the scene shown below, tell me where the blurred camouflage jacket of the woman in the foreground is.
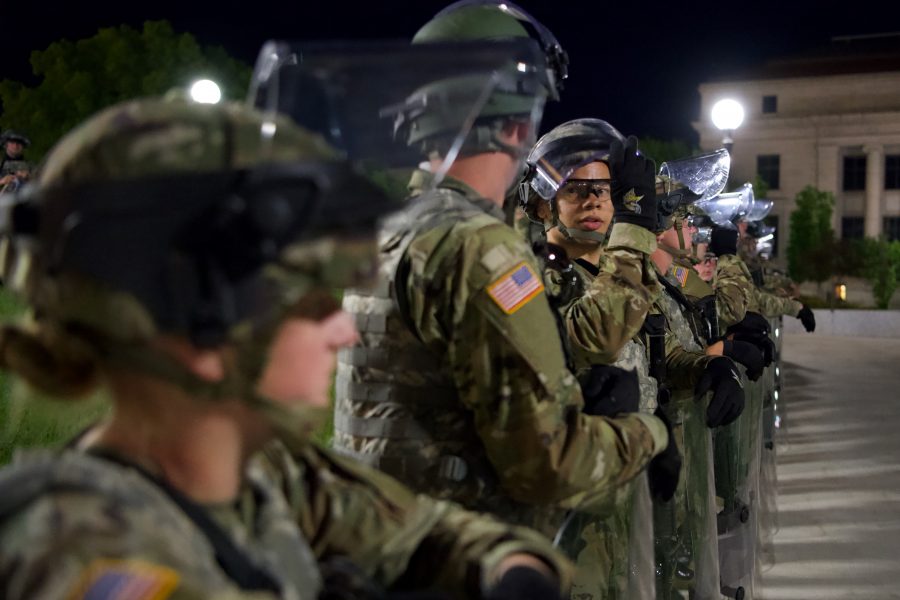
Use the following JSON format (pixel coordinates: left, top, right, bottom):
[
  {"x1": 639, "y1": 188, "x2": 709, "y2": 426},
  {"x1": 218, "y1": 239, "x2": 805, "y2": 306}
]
[{"x1": 0, "y1": 444, "x2": 571, "y2": 600}]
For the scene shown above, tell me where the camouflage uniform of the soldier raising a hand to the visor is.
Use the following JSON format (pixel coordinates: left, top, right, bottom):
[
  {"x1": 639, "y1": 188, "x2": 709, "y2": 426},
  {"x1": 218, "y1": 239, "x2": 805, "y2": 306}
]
[{"x1": 545, "y1": 241, "x2": 660, "y2": 600}]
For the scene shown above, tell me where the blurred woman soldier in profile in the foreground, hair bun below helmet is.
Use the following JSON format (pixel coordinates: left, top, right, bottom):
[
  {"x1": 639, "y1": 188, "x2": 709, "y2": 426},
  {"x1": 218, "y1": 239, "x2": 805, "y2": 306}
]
[{"x1": 0, "y1": 95, "x2": 570, "y2": 600}]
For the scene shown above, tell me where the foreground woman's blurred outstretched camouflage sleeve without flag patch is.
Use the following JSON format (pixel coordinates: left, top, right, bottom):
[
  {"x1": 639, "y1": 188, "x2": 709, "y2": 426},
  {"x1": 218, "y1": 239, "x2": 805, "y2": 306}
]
[{"x1": 266, "y1": 445, "x2": 572, "y2": 598}]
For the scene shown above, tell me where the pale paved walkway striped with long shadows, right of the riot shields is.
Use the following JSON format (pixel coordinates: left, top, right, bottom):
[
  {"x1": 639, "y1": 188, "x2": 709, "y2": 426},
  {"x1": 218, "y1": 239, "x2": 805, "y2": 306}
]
[{"x1": 761, "y1": 333, "x2": 900, "y2": 600}]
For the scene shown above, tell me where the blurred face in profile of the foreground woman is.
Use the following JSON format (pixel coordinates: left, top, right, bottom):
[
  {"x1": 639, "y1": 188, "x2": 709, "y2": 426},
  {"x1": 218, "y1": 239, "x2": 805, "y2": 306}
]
[{"x1": 258, "y1": 310, "x2": 359, "y2": 406}]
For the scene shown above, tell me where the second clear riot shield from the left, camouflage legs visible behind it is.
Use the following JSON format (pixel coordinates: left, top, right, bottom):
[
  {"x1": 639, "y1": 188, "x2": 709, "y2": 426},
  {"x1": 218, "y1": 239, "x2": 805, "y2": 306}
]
[{"x1": 653, "y1": 392, "x2": 720, "y2": 600}]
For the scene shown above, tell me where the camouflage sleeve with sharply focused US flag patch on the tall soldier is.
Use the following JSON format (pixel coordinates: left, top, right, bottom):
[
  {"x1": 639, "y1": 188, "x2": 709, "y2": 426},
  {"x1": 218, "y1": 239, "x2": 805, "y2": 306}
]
[{"x1": 406, "y1": 222, "x2": 667, "y2": 507}]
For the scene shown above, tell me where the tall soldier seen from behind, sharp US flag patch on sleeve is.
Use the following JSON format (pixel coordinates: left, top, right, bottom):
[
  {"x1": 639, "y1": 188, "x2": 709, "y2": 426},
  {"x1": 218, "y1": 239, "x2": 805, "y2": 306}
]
[{"x1": 334, "y1": 2, "x2": 668, "y2": 534}]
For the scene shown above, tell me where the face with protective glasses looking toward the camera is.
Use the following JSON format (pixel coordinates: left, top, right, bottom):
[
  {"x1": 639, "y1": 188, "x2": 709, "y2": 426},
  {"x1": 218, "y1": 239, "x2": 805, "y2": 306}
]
[{"x1": 556, "y1": 162, "x2": 613, "y2": 233}]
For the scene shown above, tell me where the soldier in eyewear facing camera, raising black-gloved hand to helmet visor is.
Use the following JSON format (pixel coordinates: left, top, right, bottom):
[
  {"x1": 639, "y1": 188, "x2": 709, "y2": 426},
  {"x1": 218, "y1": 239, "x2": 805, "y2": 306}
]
[{"x1": 520, "y1": 119, "x2": 680, "y2": 600}]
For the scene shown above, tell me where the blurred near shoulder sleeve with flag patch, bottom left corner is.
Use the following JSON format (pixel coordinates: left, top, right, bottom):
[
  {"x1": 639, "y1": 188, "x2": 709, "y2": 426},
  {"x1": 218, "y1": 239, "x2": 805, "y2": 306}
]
[{"x1": 0, "y1": 492, "x2": 276, "y2": 600}]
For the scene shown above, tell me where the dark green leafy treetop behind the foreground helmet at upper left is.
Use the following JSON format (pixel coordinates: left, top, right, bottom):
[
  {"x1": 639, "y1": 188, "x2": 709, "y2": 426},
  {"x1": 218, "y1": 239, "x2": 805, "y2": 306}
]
[{"x1": 0, "y1": 21, "x2": 251, "y2": 162}]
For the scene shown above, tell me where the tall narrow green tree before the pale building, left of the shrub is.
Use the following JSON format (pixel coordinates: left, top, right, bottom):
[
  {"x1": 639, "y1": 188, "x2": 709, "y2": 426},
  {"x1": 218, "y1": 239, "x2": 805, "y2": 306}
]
[{"x1": 787, "y1": 185, "x2": 836, "y2": 282}]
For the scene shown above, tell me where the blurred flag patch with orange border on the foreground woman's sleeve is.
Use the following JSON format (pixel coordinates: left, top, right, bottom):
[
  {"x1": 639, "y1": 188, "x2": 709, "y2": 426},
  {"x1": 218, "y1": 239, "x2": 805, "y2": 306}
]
[{"x1": 68, "y1": 559, "x2": 180, "y2": 600}]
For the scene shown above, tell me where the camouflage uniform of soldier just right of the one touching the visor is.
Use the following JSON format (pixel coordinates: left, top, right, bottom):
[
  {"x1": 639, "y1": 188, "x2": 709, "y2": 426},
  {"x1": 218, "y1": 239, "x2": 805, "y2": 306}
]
[{"x1": 654, "y1": 269, "x2": 719, "y2": 599}]
